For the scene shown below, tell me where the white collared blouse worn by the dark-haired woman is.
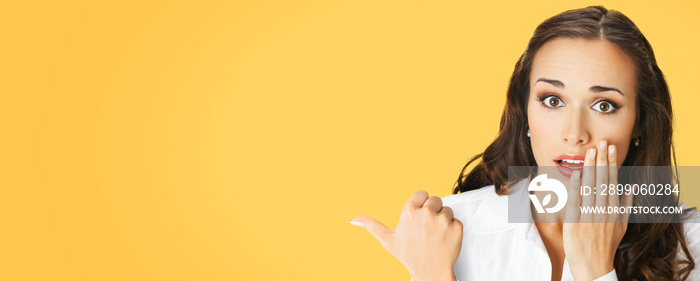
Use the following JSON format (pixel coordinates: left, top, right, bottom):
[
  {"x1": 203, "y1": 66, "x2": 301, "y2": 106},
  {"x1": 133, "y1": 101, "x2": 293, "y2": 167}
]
[{"x1": 442, "y1": 179, "x2": 700, "y2": 281}]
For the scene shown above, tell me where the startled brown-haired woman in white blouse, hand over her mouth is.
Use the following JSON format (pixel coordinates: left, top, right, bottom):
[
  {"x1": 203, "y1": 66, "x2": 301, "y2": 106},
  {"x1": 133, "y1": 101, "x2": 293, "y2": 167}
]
[{"x1": 351, "y1": 6, "x2": 700, "y2": 281}]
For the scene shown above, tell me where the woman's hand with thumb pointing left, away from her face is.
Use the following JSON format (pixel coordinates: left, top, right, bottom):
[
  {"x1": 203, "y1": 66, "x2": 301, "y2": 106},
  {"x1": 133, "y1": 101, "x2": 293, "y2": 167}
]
[{"x1": 350, "y1": 190, "x2": 463, "y2": 281}]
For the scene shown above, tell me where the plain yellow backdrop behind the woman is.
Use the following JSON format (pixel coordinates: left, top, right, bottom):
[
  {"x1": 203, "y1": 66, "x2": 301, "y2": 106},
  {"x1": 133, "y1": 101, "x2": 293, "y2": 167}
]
[{"x1": 0, "y1": 0, "x2": 700, "y2": 280}]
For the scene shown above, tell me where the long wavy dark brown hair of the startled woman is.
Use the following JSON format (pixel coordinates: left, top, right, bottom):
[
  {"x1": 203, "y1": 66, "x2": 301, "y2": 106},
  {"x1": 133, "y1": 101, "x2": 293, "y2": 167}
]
[{"x1": 453, "y1": 6, "x2": 695, "y2": 280}]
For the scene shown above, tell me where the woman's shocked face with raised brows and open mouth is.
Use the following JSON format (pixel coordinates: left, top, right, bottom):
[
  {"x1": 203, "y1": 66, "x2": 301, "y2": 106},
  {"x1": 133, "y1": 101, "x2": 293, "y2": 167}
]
[{"x1": 527, "y1": 38, "x2": 636, "y2": 178}]
